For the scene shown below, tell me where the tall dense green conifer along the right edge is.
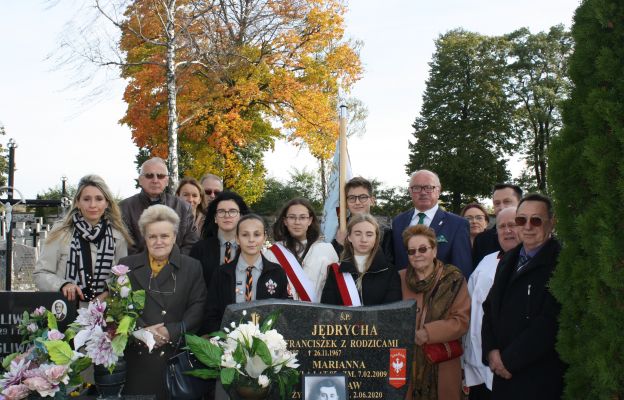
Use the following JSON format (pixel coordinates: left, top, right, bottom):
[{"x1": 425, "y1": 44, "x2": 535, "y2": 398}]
[{"x1": 550, "y1": 0, "x2": 624, "y2": 400}]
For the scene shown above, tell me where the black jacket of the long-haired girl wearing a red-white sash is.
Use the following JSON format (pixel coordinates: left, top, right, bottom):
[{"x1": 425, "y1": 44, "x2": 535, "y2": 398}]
[{"x1": 321, "y1": 250, "x2": 403, "y2": 306}]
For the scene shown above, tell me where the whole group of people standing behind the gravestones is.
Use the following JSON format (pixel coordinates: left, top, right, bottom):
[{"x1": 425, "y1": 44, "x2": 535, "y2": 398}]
[{"x1": 34, "y1": 158, "x2": 563, "y2": 400}]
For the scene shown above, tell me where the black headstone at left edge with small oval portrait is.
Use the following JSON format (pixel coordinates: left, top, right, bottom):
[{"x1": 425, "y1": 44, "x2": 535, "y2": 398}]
[{"x1": 0, "y1": 292, "x2": 77, "y2": 357}]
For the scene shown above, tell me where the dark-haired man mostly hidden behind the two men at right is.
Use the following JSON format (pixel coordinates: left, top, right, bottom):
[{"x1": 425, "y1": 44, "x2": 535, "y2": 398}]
[{"x1": 472, "y1": 183, "x2": 522, "y2": 270}]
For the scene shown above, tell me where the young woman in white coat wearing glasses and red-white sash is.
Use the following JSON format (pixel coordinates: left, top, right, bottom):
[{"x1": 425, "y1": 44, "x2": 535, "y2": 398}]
[{"x1": 265, "y1": 198, "x2": 338, "y2": 303}]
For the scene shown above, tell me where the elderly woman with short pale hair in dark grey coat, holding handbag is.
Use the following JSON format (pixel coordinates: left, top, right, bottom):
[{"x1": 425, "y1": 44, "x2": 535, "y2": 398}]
[{"x1": 120, "y1": 205, "x2": 206, "y2": 400}]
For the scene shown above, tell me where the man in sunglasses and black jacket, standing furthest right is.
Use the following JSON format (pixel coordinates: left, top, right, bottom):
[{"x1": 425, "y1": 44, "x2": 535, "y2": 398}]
[{"x1": 481, "y1": 194, "x2": 564, "y2": 400}]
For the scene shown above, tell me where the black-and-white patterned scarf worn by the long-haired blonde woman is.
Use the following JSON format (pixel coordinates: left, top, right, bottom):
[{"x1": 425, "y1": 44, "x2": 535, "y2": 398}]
[{"x1": 65, "y1": 211, "x2": 115, "y2": 301}]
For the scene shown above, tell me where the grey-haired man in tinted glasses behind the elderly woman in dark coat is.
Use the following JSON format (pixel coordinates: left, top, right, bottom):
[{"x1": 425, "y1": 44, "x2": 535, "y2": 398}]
[{"x1": 119, "y1": 157, "x2": 199, "y2": 255}]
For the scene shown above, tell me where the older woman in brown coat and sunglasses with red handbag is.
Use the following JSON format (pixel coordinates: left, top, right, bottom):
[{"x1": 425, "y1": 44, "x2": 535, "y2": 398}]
[{"x1": 399, "y1": 225, "x2": 470, "y2": 400}]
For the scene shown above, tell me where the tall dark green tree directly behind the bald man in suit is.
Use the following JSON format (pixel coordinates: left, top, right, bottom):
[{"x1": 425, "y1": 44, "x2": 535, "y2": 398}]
[{"x1": 406, "y1": 29, "x2": 514, "y2": 212}]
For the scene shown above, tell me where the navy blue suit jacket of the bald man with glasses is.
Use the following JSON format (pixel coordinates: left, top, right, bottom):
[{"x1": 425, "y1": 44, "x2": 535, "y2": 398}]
[{"x1": 392, "y1": 207, "x2": 472, "y2": 280}]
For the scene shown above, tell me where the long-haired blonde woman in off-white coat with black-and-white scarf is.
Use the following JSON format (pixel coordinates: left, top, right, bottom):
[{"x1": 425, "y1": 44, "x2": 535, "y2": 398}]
[{"x1": 34, "y1": 175, "x2": 132, "y2": 301}]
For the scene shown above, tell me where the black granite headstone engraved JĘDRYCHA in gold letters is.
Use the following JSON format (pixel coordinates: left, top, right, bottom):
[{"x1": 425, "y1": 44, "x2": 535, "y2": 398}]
[{"x1": 222, "y1": 300, "x2": 416, "y2": 400}]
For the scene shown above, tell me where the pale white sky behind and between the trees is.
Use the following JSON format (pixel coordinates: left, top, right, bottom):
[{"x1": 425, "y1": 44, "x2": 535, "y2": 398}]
[{"x1": 0, "y1": 0, "x2": 579, "y2": 198}]
